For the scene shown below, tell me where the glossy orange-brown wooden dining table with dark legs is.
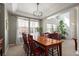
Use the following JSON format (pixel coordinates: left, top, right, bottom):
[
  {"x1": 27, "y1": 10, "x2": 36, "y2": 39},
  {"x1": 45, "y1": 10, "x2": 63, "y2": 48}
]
[{"x1": 34, "y1": 37, "x2": 63, "y2": 56}]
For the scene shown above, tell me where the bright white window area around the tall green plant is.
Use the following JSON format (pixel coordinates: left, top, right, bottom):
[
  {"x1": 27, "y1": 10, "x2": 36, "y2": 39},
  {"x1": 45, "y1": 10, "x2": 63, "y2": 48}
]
[{"x1": 46, "y1": 12, "x2": 70, "y2": 32}]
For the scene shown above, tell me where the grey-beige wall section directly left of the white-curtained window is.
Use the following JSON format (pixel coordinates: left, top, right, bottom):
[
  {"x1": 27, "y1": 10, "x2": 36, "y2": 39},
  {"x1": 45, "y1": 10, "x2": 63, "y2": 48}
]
[{"x1": 8, "y1": 13, "x2": 17, "y2": 44}]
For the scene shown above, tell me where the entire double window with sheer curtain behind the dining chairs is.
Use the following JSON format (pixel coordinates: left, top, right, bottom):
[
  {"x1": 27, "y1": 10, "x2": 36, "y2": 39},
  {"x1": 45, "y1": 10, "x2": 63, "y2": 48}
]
[{"x1": 16, "y1": 17, "x2": 40, "y2": 44}]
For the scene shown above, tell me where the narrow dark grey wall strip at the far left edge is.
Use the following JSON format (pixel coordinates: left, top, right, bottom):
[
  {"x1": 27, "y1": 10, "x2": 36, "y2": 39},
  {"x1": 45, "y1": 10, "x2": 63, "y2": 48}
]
[{"x1": 0, "y1": 3, "x2": 5, "y2": 52}]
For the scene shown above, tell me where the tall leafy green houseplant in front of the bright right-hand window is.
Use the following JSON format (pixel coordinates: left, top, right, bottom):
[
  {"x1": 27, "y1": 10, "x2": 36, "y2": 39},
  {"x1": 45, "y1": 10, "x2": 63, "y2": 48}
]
[{"x1": 57, "y1": 20, "x2": 68, "y2": 39}]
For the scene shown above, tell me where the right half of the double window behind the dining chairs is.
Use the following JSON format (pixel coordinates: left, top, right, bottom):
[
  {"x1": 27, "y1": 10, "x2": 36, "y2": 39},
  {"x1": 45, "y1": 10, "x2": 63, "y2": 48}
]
[{"x1": 30, "y1": 19, "x2": 40, "y2": 39}]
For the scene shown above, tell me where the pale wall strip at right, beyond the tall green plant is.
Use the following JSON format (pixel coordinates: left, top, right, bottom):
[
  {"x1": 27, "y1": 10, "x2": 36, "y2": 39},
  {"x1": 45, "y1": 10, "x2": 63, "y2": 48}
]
[{"x1": 70, "y1": 8, "x2": 77, "y2": 38}]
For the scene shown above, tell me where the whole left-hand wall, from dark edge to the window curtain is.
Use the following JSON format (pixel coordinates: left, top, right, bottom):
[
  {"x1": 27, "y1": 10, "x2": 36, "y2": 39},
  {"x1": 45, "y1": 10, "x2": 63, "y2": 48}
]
[{"x1": 0, "y1": 4, "x2": 16, "y2": 54}]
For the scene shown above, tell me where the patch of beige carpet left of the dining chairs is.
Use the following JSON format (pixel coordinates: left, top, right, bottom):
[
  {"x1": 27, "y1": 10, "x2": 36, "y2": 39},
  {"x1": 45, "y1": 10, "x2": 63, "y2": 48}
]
[{"x1": 6, "y1": 45, "x2": 25, "y2": 56}]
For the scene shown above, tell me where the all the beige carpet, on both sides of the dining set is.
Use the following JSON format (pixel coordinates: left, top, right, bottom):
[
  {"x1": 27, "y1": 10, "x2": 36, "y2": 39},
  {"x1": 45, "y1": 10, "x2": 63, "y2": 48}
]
[{"x1": 6, "y1": 40, "x2": 79, "y2": 56}]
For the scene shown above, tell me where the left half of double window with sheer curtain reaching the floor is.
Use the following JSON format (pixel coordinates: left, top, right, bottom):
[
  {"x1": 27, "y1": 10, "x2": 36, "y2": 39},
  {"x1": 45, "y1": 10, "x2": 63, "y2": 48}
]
[{"x1": 16, "y1": 17, "x2": 29, "y2": 44}]
